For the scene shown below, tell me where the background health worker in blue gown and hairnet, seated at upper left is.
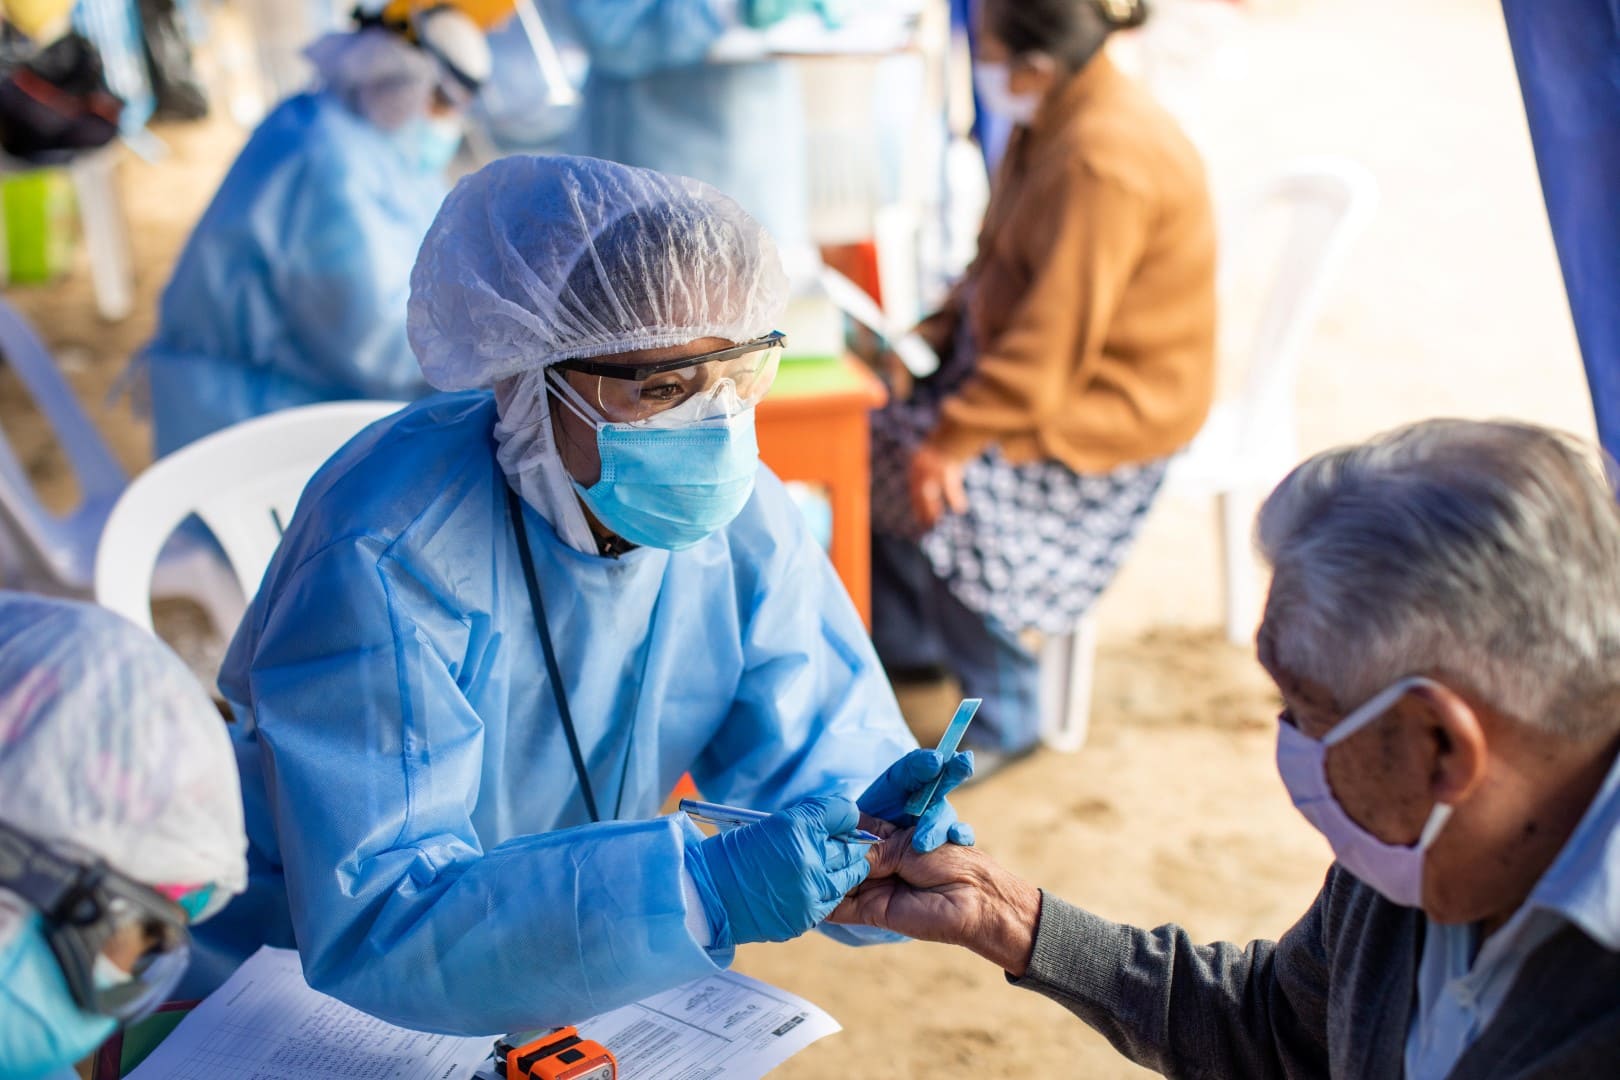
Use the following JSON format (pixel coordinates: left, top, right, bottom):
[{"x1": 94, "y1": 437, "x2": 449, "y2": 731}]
[{"x1": 139, "y1": 8, "x2": 489, "y2": 455}]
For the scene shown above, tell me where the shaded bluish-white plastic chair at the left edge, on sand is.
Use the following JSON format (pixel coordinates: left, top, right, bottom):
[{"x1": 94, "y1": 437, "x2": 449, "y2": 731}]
[{"x1": 0, "y1": 301, "x2": 241, "y2": 630}]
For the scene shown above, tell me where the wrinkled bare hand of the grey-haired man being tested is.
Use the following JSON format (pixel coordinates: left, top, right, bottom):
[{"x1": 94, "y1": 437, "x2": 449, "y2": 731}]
[{"x1": 829, "y1": 832, "x2": 1040, "y2": 976}]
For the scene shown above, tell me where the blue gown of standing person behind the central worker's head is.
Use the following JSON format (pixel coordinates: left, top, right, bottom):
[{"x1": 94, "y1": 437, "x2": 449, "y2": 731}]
[{"x1": 569, "y1": 0, "x2": 810, "y2": 249}]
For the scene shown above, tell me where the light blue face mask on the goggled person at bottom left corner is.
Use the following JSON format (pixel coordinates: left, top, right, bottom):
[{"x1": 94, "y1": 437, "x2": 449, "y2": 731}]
[{"x1": 0, "y1": 915, "x2": 118, "y2": 1080}]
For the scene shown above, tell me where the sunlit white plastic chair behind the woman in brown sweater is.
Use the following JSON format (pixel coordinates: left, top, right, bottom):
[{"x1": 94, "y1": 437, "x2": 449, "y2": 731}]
[{"x1": 1040, "y1": 159, "x2": 1379, "y2": 751}]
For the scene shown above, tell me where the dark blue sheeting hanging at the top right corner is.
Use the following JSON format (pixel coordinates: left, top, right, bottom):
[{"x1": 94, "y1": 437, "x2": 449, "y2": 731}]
[{"x1": 1502, "y1": 0, "x2": 1620, "y2": 457}]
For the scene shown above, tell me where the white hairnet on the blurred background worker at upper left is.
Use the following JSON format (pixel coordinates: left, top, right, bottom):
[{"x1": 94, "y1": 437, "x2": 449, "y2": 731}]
[{"x1": 305, "y1": 10, "x2": 489, "y2": 131}]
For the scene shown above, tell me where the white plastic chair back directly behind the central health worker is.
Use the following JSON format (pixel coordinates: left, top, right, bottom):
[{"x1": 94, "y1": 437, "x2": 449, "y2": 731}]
[{"x1": 96, "y1": 402, "x2": 403, "y2": 630}]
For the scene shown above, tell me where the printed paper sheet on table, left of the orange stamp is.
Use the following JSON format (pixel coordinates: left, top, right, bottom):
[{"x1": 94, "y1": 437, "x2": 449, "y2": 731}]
[{"x1": 130, "y1": 947, "x2": 494, "y2": 1080}]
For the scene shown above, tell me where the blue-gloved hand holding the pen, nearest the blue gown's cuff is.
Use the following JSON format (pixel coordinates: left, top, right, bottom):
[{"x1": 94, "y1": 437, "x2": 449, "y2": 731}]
[{"x1": 687, "y1": 795, "x2": 870, "y2": 946}]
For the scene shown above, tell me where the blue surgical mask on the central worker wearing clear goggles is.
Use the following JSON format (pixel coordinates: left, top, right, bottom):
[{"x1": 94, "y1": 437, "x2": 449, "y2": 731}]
[{"x1": 550, "y1": 378, "x2": 760, "y2": 551}]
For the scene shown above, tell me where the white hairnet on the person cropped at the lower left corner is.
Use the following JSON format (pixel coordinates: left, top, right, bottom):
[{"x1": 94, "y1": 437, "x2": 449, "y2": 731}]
[{"x1": 0, "y1": 593, "x2": 248, "y2": 946}]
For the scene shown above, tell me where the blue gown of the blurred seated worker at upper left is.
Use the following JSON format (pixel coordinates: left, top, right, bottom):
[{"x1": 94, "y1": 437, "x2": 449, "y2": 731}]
[{"x1": 146, "y1": 94, "x2": 446, "y2": 455}]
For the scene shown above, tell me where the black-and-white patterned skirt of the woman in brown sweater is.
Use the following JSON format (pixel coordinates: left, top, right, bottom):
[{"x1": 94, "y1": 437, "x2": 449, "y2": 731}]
[{"x1": 872, "y1": 333, "x2": 1166, "y2": 635}]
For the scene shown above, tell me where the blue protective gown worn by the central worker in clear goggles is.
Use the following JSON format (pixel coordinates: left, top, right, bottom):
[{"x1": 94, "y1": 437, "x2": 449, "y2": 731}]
[{"x1": 185, "y1": 392, "x2": 915, "y2": 1035}]
